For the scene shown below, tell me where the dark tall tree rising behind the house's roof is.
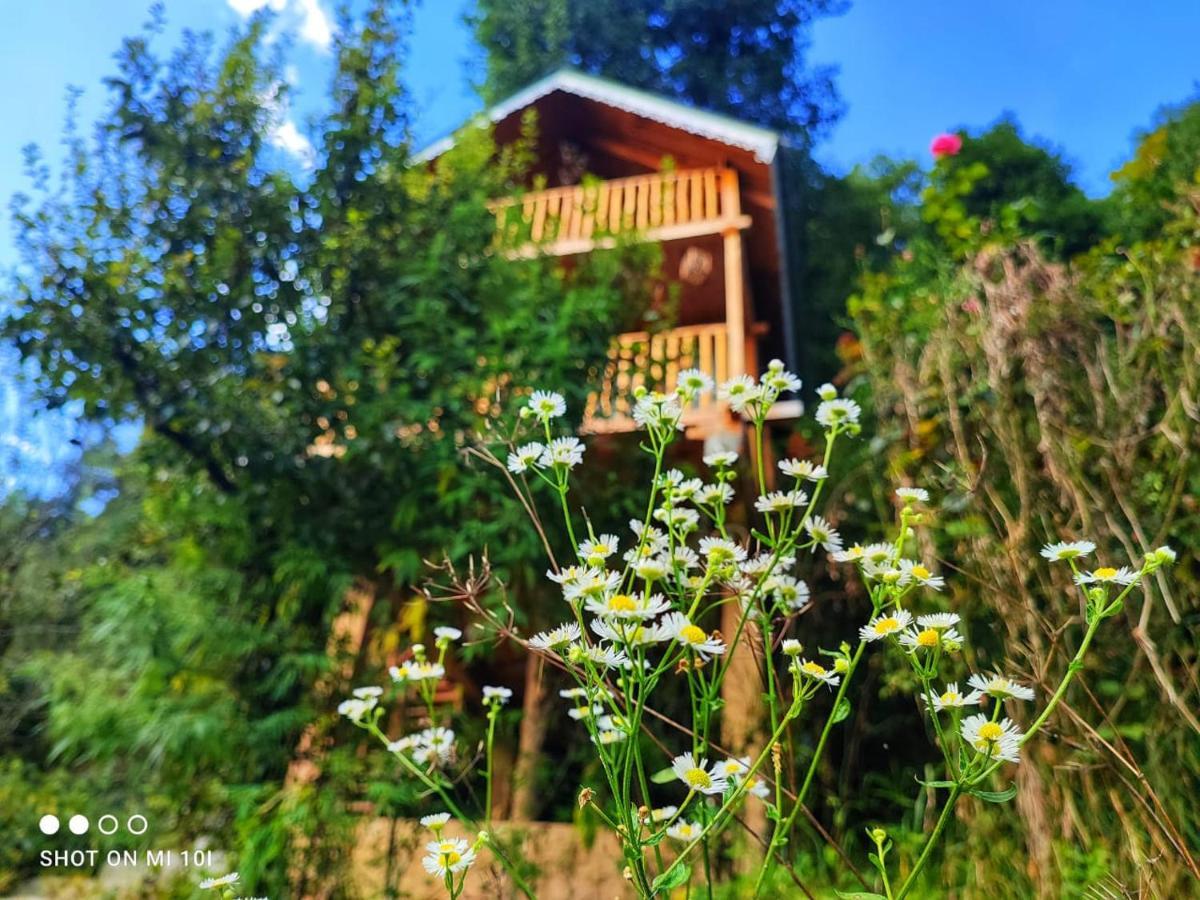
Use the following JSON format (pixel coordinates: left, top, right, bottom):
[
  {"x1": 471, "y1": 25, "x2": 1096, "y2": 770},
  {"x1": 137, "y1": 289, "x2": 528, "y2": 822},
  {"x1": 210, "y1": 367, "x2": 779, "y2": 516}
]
[{"x1": 470, "y1": 0, "x2": 846, "y2": 137}]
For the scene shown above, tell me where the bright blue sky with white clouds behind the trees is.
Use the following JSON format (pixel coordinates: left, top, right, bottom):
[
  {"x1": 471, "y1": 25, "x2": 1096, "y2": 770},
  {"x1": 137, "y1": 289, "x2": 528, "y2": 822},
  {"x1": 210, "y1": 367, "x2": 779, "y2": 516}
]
[{"x1": 0, "y1": 0, "x2": 1200, "y2": 496}]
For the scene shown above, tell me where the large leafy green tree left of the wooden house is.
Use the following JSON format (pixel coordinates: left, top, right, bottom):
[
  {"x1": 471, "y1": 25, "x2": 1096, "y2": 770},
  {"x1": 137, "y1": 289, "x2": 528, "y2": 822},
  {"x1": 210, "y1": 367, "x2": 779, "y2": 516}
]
[{"x1": 2, "y1": 0, "x2": 648, "y2": 894}]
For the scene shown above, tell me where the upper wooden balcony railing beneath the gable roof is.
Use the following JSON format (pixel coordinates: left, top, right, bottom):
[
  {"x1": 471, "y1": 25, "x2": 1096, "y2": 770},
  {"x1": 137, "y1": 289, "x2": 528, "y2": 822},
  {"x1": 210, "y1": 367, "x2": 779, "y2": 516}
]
[{"x1": 490, "y1": 168, "x2": 750, "y2": 256}]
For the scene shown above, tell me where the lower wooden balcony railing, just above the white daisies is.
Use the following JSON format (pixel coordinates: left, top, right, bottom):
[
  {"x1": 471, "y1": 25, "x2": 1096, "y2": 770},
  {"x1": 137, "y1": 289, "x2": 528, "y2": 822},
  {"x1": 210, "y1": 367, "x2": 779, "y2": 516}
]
[{"x1": 583, "y1": 323, "x2": 737, "y2": 433}]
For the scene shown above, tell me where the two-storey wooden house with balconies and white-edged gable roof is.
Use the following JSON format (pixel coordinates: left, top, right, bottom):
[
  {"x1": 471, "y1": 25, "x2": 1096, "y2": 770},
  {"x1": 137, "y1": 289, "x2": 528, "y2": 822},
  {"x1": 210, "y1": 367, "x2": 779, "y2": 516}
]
[{"x1": 419, "y1": 70, "x2": 800, "y2": 439}]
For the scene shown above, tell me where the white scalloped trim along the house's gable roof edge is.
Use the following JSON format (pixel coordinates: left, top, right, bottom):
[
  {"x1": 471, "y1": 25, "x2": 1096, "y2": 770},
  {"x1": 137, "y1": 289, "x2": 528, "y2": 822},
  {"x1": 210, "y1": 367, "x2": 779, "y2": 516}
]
[{"x1": 413, "y1": 68, "x2": 779, "y2": 163}]
